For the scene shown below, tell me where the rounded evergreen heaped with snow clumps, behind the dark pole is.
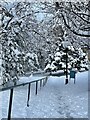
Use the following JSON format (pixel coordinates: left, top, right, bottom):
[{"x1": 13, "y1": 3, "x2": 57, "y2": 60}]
[{"x1": 45, "y1": 44, "x2": 88, "y2": 71}]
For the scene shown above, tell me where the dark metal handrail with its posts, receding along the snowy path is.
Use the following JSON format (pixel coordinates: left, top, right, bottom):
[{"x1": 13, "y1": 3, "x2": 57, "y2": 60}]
[{"x1": 0, "y1": 76, "x2": 48, "y2": 120}]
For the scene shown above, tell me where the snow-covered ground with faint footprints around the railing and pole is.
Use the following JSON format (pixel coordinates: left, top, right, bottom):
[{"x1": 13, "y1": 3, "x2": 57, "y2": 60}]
[{"x1": 0, "y1": 72, "x2": 88, "y2": 118}]
